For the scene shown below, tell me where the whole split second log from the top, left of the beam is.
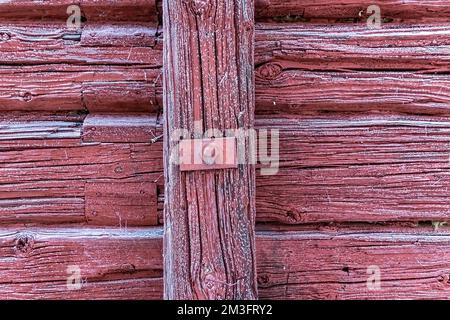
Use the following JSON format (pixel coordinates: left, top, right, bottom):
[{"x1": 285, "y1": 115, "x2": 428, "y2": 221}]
[{"x1": 0, "y1": 23, "x2": 162, "y2": 113}]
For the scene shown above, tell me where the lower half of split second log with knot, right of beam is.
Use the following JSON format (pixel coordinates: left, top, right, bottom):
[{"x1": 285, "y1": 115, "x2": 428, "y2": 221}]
[{"x1": 256, "y1": 70, "x2": 450, "y2": 115}]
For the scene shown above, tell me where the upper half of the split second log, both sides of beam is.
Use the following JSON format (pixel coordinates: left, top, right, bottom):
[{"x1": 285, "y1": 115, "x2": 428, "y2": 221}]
[{"x1": 14, "y1": 23, "x2": 450, "y2": 74}]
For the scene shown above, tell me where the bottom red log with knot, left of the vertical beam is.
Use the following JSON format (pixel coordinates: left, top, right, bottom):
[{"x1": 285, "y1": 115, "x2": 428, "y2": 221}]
[{"x1": 0, "y1": 228, "x2": 162, "y2": 299}]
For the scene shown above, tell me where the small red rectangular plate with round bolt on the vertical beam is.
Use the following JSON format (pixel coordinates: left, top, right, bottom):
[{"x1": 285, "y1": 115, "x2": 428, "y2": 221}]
[{"x1": 178, "y1": 137, "x2": 237, "y2": 171}]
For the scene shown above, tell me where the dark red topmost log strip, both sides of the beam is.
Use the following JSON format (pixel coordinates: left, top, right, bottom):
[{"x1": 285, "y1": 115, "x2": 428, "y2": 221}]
[{"x1": 0, "y1": 0, "x2": 450, "y2": 23}]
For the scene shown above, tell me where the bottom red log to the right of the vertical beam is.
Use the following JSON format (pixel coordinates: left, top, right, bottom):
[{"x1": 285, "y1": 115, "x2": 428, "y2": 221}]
[{"x1": 73, "y1": 227, "x2": 450, "y2": 300}]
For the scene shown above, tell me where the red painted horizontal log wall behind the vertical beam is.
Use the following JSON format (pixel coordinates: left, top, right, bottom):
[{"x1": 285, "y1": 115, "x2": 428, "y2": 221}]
[{"x1": 0, "y1": 0, "x2": 450, "y2": 299}]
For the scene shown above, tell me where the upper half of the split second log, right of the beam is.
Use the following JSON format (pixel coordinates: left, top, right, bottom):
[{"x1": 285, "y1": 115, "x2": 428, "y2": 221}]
[{"x1": 255, "y1": 23, "x2": 450, "y2": 72}]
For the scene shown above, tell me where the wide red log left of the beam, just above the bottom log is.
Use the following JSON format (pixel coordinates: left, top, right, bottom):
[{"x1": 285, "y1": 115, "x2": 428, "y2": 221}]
[{"x1": 0, "y1": 113, "x2": 163, "y2": 226}]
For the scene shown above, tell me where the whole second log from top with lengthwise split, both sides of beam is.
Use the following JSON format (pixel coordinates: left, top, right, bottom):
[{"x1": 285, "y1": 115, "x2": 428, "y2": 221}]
[{"x1": 6, "y1": 24, "x2": 450, "y2": 114}]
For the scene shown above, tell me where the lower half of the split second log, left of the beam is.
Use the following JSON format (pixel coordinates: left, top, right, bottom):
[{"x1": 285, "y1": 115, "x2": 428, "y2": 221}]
[{"x1": 0, "y1": 65, "x2": 161, "y2": 113}]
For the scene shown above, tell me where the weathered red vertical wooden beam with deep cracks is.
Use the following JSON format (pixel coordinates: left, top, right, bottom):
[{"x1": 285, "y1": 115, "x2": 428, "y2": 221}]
[{"x1": 164, "y1": 0, "x2": 257, "y2": 299}]
